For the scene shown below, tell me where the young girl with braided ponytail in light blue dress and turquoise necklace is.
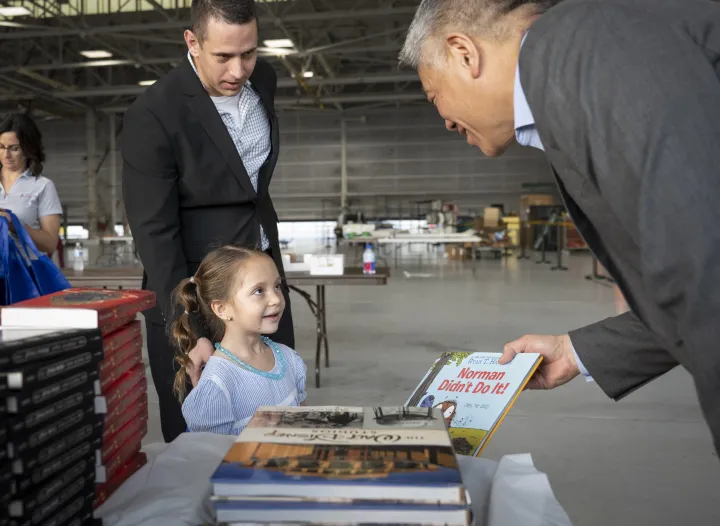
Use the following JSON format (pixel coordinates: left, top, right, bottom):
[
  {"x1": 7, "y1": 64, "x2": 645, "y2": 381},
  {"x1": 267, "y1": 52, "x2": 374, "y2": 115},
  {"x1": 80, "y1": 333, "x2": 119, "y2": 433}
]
[{"x1": 173, "y1": 246, "x2": 306, "y2": 435}]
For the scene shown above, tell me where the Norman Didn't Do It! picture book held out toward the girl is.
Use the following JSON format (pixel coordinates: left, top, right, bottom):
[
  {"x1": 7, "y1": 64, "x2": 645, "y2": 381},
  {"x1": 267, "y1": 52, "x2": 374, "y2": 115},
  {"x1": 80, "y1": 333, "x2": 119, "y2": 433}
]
[{"x1": 406, "y1": 352, "x2": 542, "y2": 456}]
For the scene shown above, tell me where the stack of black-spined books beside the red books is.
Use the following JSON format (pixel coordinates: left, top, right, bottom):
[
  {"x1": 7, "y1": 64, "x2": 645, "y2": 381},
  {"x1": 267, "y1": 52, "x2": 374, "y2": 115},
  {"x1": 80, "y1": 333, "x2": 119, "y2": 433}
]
[{"x1": 0, "y1": 329, "x2": 103, "y2": 524}]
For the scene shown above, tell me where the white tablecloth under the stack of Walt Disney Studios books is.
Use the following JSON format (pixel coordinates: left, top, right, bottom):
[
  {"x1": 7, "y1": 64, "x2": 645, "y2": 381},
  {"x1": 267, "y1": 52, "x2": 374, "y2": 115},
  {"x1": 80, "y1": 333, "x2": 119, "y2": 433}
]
[{"x1": 96, "y1": 433, "x2": 571, "y2": 526}]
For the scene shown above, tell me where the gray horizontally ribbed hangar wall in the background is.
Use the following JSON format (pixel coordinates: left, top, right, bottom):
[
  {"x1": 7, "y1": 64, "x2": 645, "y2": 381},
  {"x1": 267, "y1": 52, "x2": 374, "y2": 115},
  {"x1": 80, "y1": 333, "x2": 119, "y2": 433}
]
[{"x1": 40, "y1": 106, "x2": 552, "y2": 227}]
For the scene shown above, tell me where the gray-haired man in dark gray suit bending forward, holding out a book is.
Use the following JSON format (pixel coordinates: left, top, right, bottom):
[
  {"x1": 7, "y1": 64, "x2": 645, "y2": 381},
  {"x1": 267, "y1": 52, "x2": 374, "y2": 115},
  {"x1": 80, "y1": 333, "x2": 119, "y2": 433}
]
[{"x1": 401, "y1": 0, "x2": 720, "y2": 458}]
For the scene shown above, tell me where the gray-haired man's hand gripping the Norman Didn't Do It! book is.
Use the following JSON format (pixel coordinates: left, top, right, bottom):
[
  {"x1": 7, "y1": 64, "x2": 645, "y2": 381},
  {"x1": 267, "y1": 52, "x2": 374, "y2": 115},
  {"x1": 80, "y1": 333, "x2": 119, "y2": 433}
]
[{"x1": 500, "y1": 334, "x2": 580, "y2": 389}]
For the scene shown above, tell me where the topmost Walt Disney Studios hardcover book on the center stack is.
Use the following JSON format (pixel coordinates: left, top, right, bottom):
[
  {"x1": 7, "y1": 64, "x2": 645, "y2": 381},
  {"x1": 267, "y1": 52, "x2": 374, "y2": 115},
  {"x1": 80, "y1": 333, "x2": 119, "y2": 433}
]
[{"x1": 211, "y1": 407, "x2": 465, "y2": 504}]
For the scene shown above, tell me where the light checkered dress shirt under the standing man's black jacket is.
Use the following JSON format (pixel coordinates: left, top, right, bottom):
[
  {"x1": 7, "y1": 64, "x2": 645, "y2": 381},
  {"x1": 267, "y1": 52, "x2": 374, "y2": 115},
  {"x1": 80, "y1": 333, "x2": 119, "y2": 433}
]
[{"x1": 188, "y1": 53, "x2": 272, "y2": 250}]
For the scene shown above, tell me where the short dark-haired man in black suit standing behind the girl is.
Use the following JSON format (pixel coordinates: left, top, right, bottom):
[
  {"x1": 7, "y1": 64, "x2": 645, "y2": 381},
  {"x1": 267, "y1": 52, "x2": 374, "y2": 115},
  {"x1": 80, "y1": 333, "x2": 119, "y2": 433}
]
[{"x1": 121, "y1": 0, "x2": 294, "y2": 442}]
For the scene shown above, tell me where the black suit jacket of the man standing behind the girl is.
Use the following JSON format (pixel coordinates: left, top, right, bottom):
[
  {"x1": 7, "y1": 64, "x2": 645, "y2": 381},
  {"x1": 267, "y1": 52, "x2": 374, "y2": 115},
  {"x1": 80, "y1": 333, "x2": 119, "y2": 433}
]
[{"x1": 121, "y1": 57, "x2": 294, "y2": 347}]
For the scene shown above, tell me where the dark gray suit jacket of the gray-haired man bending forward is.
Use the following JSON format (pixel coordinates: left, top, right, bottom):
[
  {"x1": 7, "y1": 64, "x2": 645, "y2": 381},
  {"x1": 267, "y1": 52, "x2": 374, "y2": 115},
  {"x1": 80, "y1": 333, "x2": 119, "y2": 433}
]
[{"x1": 520, "y1": 0, "x2": 720, "y2": 451}]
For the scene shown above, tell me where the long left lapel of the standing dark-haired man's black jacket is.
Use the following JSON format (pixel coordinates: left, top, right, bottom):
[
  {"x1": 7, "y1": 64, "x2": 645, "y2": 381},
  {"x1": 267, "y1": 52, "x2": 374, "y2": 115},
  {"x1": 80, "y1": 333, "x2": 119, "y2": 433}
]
[{"x1": 181, "y1": 57, "x2": 257, "y2": 199}]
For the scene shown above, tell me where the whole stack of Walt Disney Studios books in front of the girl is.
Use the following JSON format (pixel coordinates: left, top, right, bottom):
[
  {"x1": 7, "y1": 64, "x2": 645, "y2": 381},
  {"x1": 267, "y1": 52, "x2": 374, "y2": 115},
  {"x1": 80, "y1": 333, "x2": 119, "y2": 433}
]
[{"x1": 211, "y1": 407, "x2": 471, "y2": 526}]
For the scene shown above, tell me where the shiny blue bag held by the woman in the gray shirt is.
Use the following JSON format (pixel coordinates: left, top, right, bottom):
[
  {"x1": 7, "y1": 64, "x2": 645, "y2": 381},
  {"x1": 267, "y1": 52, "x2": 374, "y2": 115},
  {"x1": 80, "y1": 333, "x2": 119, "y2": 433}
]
[{"x1": 0, "y1": 210, "x2": 71, "y2": 305}]
